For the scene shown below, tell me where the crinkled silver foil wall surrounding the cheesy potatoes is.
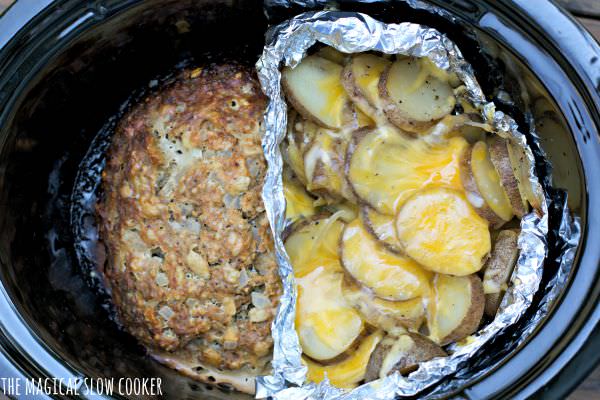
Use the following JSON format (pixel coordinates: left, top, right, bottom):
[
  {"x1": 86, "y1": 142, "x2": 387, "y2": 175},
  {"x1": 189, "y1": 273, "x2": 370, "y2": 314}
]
[{"x1": 256, "y1": 11, "x2": 580, "y2": 400}]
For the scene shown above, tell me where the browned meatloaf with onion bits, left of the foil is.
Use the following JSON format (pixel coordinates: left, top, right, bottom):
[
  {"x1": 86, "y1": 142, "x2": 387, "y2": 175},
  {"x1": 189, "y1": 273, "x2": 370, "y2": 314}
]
[{"x1": 98, "y1": 65, "x2": 281, "y2": 370}]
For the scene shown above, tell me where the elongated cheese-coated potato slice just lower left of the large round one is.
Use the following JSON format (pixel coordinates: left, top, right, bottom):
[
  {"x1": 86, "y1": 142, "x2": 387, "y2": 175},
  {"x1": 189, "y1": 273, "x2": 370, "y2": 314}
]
[{"x1": 340, "y1": 219, "x2": 431, "y2": 301}]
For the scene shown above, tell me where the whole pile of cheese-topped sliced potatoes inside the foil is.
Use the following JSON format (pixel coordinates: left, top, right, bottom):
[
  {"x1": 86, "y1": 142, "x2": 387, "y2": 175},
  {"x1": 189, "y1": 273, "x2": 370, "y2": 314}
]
[{"x1": 282, "y1": 47, "x2": 539, "y2": 388}]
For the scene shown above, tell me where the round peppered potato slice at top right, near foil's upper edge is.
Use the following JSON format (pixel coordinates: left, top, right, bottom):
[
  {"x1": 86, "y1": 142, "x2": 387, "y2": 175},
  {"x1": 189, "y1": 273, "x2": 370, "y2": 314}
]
[{"x1": 379, "y1": 58, "x2": 456, "y2": 132}]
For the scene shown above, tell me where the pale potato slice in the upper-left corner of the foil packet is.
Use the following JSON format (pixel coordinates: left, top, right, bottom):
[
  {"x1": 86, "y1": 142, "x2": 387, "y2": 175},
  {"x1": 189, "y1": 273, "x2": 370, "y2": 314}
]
[{"x1": 281, "y1": 55, "x2": 348, "y2": 129}]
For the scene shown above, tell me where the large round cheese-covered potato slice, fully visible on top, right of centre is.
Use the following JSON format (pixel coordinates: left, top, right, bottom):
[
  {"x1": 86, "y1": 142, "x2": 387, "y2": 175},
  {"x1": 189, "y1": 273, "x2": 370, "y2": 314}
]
[{"x1": 396, "y1": 187, "x2": 491, "y2": 276}]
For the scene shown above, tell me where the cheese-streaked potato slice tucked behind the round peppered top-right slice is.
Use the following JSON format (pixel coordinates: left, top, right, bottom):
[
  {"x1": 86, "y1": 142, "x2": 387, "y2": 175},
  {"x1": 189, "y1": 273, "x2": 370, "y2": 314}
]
[{"x1": 342, "y1": 53, "x2": 390, "y2": 120}]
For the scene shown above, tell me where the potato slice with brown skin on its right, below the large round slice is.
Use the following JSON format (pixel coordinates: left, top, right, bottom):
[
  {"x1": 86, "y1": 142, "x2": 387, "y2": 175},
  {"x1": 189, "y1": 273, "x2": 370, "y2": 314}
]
[{"x1": 427, "y1": 274, "x2": 485, "y2": 346}]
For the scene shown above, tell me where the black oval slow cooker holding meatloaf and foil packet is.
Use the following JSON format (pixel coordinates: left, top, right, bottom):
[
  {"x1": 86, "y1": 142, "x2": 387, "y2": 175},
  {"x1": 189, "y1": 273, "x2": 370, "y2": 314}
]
[{"x1": 0, "y1": 0, "x2": 600, "y2": 399}]
